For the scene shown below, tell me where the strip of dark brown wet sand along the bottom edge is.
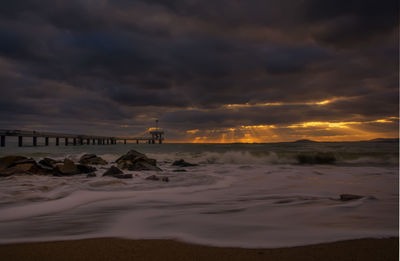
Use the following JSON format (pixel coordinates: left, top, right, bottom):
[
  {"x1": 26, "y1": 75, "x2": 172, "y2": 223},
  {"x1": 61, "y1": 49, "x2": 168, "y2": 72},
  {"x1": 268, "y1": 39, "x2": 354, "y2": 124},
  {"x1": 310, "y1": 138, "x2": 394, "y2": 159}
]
[{"x1": 0, "y1": 238, "x2": 399, "y2": 261}]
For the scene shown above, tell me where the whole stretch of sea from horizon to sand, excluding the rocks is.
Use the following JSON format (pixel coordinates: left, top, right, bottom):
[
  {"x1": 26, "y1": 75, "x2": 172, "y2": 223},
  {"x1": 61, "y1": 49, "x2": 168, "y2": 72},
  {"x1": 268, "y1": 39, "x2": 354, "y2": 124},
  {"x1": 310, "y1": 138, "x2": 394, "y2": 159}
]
[{"x1": 0, "y1": 142, "x2": 399, "y2": 248}]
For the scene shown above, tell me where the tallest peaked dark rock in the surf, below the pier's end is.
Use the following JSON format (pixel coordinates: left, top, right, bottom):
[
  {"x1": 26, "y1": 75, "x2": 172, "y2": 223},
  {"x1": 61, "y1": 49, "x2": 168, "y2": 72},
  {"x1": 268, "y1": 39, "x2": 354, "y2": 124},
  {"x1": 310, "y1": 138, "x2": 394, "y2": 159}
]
[{"x1": 116, "y1": 150, "x2": 161, "y2": 171}]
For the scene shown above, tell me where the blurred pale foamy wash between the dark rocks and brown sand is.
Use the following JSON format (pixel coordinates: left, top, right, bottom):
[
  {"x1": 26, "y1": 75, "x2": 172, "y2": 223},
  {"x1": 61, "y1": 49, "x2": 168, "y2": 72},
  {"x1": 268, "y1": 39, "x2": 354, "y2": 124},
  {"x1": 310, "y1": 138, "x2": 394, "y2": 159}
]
[{"x1": 0, "y1": 162, "x2": 398, "y2": 247}]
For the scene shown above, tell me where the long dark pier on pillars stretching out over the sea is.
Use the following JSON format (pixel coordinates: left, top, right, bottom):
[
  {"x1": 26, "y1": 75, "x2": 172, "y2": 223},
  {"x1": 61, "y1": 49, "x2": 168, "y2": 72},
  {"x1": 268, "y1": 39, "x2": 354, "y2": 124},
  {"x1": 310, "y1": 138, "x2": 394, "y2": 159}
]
[{"x1": 0, "y1": 128, "x2": 164, "y2": 147}]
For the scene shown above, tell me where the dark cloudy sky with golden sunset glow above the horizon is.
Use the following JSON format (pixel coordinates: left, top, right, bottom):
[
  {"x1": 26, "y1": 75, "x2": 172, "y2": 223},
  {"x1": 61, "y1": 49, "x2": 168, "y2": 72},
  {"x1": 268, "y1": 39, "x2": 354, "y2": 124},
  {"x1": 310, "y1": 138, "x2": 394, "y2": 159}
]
[{"x1": 0, "y1": 0, "x2": 399, "y2": 142}]
